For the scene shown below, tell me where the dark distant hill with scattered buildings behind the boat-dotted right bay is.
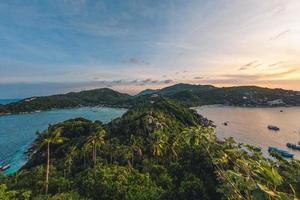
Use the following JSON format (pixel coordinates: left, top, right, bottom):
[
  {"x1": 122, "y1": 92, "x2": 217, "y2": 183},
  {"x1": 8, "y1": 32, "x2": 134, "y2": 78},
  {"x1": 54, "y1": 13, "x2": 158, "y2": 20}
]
[{"x1": 139, "y1": 84, "x2": 300, "y2": 107}]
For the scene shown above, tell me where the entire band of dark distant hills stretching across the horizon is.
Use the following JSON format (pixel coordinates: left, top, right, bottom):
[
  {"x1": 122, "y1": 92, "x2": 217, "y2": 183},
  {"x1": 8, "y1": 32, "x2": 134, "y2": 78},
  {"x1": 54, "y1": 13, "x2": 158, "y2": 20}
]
[{"x1": 0, "y1": 83, "x2": 300, "y2": 115}]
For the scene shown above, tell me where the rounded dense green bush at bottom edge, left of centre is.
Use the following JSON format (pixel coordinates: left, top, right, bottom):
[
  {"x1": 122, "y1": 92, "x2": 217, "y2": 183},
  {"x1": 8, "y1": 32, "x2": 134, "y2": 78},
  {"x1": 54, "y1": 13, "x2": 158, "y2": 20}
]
[{"x1": 78, "y1": 165, "x2": 162, "y2": 200}]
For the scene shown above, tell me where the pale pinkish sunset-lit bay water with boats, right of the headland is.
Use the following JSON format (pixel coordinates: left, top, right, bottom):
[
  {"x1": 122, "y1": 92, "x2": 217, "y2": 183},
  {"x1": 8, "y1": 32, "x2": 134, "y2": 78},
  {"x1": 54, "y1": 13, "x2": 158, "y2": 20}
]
[{"x1": 195, "y1": 105, "x2": 300, "y2": 159}]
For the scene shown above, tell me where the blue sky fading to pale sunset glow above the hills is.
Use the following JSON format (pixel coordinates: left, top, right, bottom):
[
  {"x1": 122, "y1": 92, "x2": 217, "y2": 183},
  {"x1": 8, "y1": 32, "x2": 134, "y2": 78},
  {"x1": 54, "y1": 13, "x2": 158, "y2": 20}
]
[{"x1": 0, "y1": 0, "x2": 300, "y2": 98}]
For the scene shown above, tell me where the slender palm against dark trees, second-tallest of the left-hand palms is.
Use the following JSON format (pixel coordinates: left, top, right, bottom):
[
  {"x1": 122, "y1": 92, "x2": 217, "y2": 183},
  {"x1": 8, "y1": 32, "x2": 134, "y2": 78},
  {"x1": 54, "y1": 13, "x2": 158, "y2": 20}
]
[{"x1": 88, "y1": 126, "x2": 105, "y2": 165}]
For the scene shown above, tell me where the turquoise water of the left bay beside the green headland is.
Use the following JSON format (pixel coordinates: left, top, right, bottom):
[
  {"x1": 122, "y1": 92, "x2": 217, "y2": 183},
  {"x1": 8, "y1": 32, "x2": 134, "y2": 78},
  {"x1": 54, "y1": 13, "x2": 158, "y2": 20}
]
[{"x1": 0, "y1": 107, "x2": 126, "y2": 174}]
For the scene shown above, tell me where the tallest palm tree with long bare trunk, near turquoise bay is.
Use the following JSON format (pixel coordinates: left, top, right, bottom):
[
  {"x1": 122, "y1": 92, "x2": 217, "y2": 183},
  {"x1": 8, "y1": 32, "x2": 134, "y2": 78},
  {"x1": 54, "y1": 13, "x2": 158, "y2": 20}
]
[{"x1": 41, "y1": 126, "x2": 64, "y2": 195}]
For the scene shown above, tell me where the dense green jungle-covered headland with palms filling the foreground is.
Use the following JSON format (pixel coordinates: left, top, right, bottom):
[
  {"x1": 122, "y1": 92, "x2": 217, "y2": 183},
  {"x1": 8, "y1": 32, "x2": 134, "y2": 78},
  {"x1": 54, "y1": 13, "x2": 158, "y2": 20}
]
[{"x1": 0, "y1": 98, "x2": 300, "y2": 200}]
